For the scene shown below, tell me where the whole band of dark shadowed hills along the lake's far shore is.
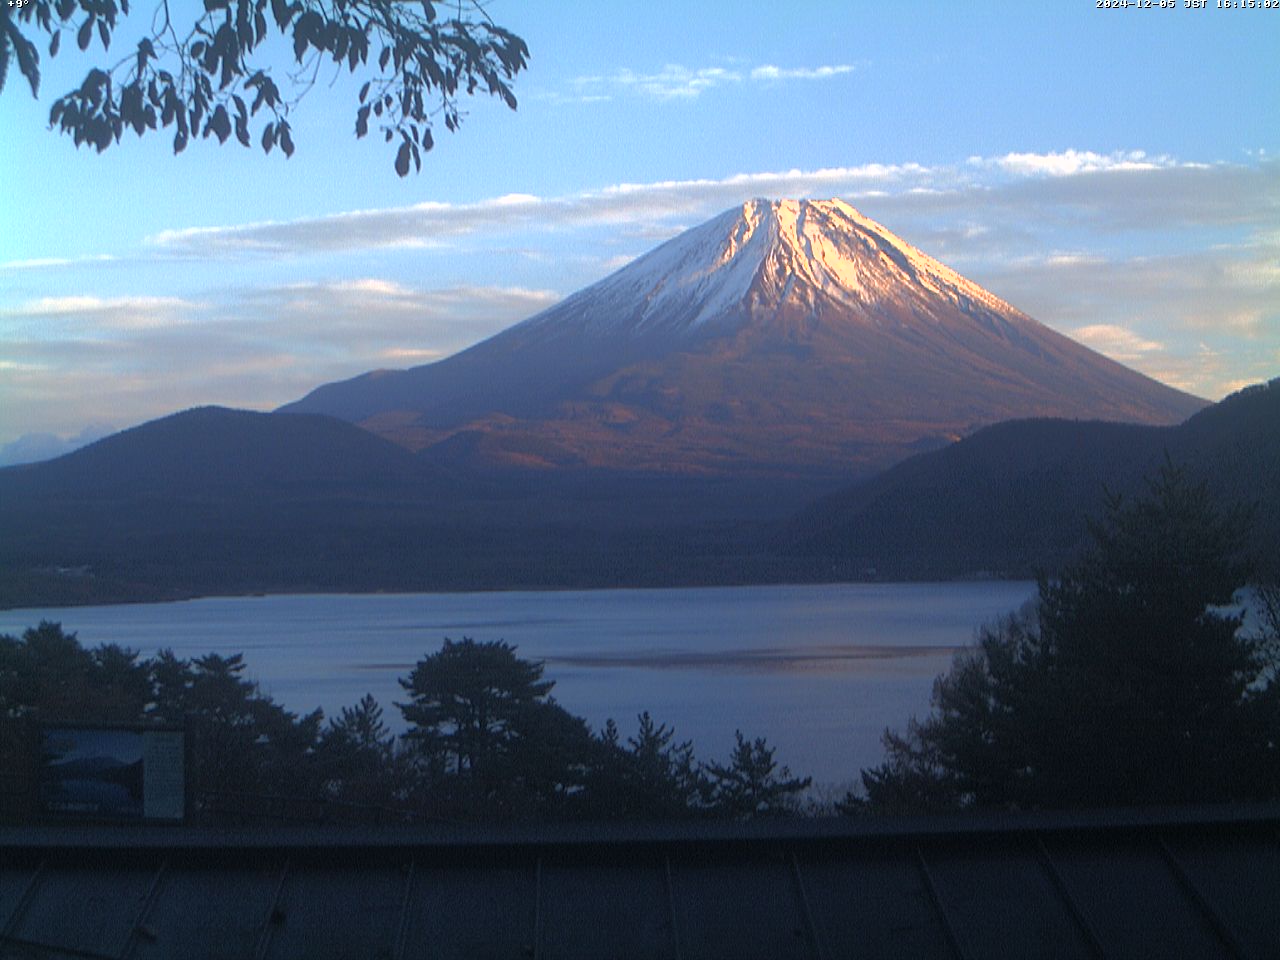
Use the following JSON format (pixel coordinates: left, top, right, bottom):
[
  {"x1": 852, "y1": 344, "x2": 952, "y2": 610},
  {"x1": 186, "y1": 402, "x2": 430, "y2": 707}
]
[{"x1": 0, "y1": 381, "x2": 1280, "y2": 607}]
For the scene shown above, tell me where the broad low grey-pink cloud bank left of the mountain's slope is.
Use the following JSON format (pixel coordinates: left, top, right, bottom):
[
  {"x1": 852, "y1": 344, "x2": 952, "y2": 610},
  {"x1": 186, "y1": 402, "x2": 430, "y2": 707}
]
[{"x1": 0, "y1": 276, "x2": 558, "y2": 442}]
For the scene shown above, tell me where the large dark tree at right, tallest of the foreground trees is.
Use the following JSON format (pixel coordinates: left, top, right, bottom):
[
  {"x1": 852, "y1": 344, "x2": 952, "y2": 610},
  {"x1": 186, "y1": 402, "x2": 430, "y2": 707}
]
[{"x1": 863, "y1": 462, "x2": 1277, "y2": 809}]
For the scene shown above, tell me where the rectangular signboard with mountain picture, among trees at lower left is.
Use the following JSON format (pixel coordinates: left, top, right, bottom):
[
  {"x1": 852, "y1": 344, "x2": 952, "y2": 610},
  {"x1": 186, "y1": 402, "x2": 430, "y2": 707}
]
[{"x1": 40, "y1": 726, "x2": 187, "y2": 820}]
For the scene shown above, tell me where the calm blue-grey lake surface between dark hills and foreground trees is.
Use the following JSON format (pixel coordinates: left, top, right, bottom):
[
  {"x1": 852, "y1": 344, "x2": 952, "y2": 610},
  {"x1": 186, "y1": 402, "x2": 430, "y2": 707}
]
[{"x1": 0, "y1": 581, "x2": 1036, "y2": 783}]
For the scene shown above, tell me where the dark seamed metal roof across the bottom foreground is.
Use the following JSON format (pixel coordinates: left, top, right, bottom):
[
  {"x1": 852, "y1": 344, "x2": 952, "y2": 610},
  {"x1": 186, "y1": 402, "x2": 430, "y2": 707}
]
[{"x1": 0, "y1": 805, "x2": 1280, "y2": 960}]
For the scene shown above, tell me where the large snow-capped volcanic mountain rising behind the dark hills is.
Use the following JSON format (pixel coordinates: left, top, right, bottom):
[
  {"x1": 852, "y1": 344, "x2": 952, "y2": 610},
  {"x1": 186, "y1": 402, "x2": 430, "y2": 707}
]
[{"x1": 285, "y1": 200, "x2": 1204, "y2": 476}]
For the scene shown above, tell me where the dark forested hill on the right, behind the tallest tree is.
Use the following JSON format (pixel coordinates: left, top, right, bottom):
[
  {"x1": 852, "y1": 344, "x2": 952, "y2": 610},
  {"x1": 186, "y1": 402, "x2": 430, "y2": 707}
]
[{"x1": 780, "y1": 379, "x2": 1280, "y2": 579}]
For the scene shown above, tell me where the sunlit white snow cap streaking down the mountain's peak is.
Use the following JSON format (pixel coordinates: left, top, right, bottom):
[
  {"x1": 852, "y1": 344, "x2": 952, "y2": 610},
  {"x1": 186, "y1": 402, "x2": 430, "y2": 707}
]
[{"x1": 520, "y1": 200, "x2": 1021, "y2": 343}]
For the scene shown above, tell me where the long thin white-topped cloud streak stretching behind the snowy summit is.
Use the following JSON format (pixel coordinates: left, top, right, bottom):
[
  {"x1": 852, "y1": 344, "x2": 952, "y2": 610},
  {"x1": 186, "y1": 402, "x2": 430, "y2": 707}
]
[{"x1": 147, "y1": 150, "x2": 1280, "y2": 259}]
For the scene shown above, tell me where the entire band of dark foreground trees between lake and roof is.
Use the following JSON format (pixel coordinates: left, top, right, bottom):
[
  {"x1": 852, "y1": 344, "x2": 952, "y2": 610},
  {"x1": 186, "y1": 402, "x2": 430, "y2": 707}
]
[{"x1": 0, "y1": 461, "x2": 1280, "y2": 822}]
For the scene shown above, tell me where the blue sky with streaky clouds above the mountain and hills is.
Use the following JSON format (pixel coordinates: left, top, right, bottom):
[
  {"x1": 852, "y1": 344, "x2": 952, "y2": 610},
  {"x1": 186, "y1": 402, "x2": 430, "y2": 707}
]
[{"x1": 0, "y1": 0, "x2": 1280, "y2": 462}]
